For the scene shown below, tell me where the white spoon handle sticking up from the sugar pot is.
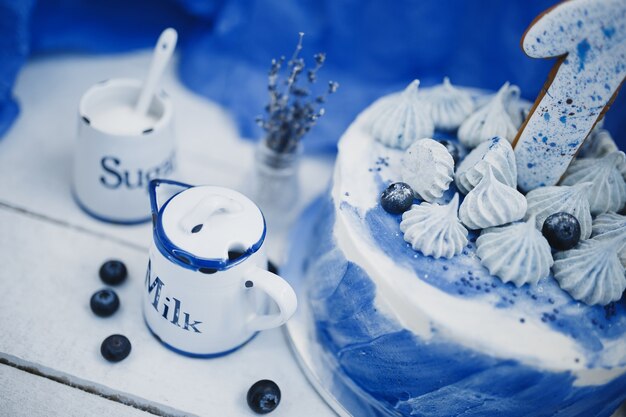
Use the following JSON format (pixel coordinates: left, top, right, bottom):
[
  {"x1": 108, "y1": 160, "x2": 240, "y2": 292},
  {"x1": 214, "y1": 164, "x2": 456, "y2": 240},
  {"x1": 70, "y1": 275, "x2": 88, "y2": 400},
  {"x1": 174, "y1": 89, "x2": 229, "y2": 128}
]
[{"x1": 135, "y1": 28, "x2": 178, "y2": 115}]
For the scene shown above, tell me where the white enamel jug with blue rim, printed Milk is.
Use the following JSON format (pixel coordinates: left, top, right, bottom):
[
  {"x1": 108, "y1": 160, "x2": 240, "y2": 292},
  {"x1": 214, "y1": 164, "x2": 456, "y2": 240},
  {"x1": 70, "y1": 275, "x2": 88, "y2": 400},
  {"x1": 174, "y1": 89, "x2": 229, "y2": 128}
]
[{"x1": 143, "y1": 180, "x2": 297, "y2": 357}]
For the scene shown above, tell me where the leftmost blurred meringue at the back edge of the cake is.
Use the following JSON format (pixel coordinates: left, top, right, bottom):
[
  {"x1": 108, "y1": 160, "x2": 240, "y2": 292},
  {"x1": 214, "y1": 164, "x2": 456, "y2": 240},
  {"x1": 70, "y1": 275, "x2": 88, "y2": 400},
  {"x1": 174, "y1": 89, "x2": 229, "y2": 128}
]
[{"x1": 369, "y1": 80, "x2": 435, "y2": 149}]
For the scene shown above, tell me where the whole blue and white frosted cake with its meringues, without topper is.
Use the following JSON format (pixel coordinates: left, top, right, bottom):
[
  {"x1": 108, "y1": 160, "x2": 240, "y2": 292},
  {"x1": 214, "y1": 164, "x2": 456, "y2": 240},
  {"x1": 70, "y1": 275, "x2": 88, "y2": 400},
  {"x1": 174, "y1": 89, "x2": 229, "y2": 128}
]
[{"x1": 287, "y1": 80, "x2": 626, "y2": 417}]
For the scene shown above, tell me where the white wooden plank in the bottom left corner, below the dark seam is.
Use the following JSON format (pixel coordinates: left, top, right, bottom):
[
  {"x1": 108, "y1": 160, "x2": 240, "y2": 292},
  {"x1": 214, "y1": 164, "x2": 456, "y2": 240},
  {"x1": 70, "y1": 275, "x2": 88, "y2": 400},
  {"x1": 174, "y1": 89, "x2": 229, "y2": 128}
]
[{"x1": 0, "y1": 365, "x2": 154, "y2": 417}]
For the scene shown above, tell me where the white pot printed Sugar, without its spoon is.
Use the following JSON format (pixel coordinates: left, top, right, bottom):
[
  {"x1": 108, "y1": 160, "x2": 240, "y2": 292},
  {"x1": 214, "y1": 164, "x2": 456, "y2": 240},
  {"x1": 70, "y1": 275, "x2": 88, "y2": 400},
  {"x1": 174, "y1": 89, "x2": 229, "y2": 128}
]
[{"x1": 73, "y1": 78, "x2": 176, "y2": 224}]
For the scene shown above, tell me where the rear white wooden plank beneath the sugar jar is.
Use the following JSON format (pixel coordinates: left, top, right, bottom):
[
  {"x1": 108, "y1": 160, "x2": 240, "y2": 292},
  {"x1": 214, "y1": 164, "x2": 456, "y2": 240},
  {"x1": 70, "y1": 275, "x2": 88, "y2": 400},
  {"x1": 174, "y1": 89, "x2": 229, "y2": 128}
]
[{"x1": 0, "y1": 52, "x2": 332, "y2": 254}]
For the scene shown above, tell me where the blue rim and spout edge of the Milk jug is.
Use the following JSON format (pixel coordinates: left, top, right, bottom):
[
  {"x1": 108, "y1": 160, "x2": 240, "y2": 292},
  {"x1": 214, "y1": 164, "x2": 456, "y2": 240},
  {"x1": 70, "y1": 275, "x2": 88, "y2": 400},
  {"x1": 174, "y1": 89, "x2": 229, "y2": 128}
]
[{"x1": 149, "y1": 179, "x2": 267, "y2": 274}]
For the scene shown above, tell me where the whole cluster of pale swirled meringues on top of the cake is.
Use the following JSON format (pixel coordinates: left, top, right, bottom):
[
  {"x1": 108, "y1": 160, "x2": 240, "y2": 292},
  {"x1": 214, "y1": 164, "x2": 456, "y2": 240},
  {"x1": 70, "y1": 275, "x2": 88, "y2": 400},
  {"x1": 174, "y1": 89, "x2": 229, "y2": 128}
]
[{"x1": 368, "y1": 78, "x2": 626, "y2": 305}]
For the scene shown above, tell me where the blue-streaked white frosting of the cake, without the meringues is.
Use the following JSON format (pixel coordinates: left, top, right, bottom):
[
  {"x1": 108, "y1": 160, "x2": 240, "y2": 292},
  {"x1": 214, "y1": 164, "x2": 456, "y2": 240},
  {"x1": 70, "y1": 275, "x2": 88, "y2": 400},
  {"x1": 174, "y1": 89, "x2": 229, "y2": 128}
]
[{"x1": 286, "y1": 83, "x2": 626, "y2": 416}]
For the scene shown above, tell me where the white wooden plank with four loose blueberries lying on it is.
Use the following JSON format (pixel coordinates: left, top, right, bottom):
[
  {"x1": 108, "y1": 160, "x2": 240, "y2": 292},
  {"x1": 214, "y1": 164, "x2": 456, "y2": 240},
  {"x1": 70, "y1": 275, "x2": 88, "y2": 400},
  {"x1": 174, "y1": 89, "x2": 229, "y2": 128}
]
[{"x1": 0, "y1": 208, "x2": 332, "y2": 417}]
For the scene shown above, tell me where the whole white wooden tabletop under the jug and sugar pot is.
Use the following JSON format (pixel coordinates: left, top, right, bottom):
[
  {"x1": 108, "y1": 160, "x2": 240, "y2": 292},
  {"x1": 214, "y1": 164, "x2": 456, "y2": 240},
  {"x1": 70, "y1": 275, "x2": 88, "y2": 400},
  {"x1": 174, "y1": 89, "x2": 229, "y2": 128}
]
[{"x1": 0, "y1": 52, "x2": 334, "y2": 417}]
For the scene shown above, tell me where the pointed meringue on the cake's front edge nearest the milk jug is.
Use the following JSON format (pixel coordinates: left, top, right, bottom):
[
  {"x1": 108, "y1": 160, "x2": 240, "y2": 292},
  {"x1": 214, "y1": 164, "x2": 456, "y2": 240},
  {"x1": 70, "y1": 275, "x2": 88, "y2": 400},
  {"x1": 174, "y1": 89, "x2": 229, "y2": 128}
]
[{"x1": 400, "y1": 194, "x2": 467, "y2": 259}]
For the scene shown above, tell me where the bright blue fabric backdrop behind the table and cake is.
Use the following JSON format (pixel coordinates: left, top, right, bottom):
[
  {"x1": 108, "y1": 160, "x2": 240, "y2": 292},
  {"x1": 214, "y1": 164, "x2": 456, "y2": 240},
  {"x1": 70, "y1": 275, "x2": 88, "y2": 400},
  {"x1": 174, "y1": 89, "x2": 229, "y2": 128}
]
[{"x1": 0, "y1": 0, "x2": 626, "y2": 151}]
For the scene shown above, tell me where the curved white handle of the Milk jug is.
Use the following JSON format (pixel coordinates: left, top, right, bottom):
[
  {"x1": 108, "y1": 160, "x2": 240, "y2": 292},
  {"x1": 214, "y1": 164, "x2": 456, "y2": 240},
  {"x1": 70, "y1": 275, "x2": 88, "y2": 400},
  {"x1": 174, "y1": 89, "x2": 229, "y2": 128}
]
[{"x1": 244, "y1": 266, "x2": 298, "y2": 331}]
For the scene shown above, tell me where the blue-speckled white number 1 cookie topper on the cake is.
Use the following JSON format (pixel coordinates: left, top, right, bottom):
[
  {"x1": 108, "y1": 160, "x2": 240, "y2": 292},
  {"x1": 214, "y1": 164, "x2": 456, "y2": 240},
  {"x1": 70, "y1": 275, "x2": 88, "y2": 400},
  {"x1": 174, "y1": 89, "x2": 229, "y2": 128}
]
[{"x1": 513, "y1": 0, "x2": 626, "y2": 191}]
